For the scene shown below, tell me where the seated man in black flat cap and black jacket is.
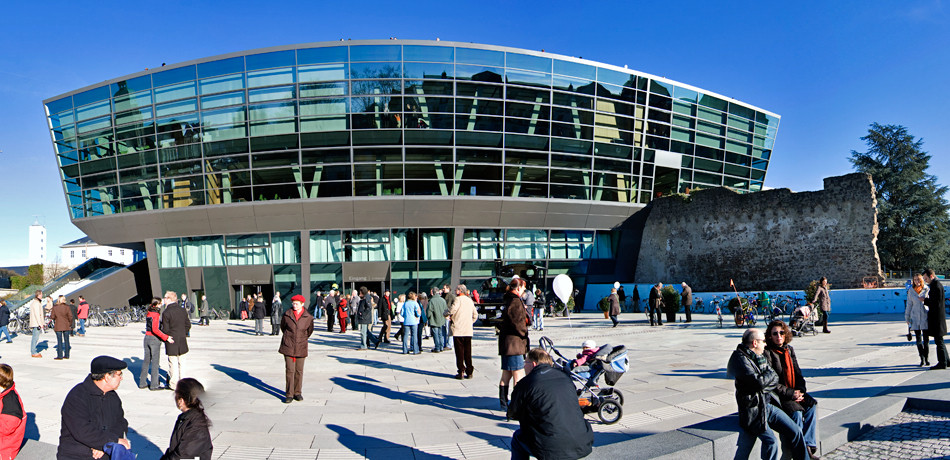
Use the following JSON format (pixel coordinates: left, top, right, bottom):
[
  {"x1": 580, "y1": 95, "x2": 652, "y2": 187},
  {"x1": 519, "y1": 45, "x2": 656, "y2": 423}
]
[{"x1": 56, "y1": 356, "x2": 131, "y2": 459}]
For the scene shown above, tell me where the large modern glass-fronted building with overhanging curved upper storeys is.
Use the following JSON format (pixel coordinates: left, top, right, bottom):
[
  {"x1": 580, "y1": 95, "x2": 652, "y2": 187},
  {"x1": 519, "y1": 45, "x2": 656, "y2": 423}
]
[{"x1": 44, "y1": 40, "x2": 779, "y2": 312}]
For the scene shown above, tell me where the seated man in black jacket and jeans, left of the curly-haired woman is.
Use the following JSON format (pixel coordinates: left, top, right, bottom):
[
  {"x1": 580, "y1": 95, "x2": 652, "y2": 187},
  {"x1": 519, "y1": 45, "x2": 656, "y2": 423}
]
[{"x1": 727, "y1": 329, "x2": 808, "y2": 460}]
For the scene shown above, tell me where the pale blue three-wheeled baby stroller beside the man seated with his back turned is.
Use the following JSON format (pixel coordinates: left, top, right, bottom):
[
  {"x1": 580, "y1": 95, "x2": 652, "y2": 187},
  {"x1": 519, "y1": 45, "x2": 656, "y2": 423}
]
[{"x1": 539, "y1": 337, "x2": 629, "y2": 425}]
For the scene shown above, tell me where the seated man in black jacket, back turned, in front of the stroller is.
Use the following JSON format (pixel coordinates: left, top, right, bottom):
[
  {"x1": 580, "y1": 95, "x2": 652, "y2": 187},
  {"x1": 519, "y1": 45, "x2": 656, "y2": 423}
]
[{"x1": 508, "y1": 348, "x2": 594, "y2": 460}]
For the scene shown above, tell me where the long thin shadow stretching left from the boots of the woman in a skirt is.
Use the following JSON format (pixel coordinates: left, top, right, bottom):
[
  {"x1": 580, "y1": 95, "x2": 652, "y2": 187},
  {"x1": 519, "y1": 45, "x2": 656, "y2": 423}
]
[{"x1": 330, "y1": 375, "x2": 498, "y2": 419}]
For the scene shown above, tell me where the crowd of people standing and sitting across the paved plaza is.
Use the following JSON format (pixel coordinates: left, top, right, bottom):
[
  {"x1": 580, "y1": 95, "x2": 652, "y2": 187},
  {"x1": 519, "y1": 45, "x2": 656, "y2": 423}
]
[{"x1": 0, "y1": 270, "x2": 947, "y2": 459}]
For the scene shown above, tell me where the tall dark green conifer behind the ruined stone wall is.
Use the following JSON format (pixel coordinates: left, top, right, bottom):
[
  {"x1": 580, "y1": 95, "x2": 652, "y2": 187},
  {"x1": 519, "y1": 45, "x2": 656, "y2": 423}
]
[{"x1": 851, "y1": 123, "x2": 950, "y2": 271}]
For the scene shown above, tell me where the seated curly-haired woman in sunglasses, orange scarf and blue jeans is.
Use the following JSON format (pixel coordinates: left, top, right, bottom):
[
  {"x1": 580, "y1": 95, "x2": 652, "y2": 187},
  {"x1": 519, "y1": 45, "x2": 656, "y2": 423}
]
[{"x1": 765, "y1": 320, "x2": 818, "y2": 455}]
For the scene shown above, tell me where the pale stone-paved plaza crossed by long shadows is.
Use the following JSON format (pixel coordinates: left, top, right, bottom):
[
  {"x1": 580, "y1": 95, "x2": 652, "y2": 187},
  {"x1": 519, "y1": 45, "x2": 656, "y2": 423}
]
[{"x1": 0, "y1": 313, "x2": 950, "y2": 460}]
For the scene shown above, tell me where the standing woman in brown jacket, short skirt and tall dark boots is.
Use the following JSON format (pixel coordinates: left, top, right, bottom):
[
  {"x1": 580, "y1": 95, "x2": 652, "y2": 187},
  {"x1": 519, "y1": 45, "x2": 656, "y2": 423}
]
[{"x1": 498, "y1": 278, "x2": 528, "y2": 410}]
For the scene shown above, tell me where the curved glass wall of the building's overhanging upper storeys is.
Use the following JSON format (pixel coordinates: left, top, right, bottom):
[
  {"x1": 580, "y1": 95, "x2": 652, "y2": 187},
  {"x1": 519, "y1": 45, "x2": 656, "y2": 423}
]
[{"x1": 45, "y1": 42, "x2": 779, "y2": 218}]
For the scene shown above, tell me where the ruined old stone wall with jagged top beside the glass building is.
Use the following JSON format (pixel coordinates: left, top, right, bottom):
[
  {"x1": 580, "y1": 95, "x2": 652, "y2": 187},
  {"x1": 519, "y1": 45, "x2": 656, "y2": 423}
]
[{"x1": 636, "y1": 173, "x2": 883, "y2": 291}]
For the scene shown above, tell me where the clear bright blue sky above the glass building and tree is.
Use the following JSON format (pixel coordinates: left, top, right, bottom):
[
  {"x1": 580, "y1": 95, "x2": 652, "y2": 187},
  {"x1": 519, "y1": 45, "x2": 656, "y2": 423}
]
[{"x1": 0, "y1": 0, "x2": 950, "y2": 266}]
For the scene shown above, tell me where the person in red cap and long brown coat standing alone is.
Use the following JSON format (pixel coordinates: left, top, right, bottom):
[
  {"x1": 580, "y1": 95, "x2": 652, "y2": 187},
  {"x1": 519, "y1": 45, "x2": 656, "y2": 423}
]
[{"x1": 277, "y1": 294, "x2": 313, "y2": 404}]
